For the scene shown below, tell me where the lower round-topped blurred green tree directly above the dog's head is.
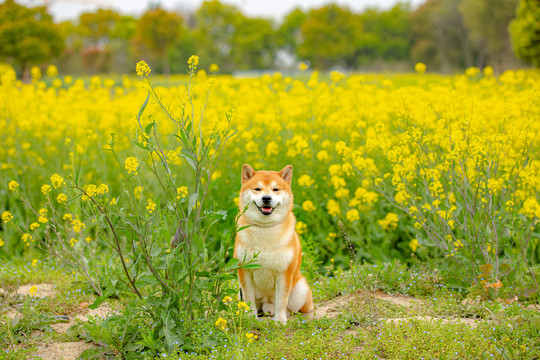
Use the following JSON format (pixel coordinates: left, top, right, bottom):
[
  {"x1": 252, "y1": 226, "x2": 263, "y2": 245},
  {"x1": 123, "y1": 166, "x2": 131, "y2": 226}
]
[{"x1": 231, "y1": 16, "x2": 276, "y2": 70}]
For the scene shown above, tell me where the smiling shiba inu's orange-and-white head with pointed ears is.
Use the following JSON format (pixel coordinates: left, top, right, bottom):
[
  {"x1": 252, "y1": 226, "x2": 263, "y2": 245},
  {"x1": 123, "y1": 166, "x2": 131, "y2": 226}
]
[{"x1": 238, "y1": 165, "x2": 293, "y2": 225}]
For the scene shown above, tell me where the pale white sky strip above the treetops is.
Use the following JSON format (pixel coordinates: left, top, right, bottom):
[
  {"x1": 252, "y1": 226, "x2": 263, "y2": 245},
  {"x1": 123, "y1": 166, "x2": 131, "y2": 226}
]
[{"x1": 19, "y1": 0, "x2": 426, "y2": 21}]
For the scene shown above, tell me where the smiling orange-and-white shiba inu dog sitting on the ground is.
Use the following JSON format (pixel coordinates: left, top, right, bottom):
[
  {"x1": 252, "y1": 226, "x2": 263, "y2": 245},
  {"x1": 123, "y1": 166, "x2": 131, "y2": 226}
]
[{"x1": 234, "y1": 165, "x2": 313, "y2": 322}]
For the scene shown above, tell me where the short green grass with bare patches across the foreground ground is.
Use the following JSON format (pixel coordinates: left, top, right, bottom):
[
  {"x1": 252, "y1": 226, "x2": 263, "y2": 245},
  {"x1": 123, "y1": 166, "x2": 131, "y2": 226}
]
[{"x1": 0, "y1": 262, "x2": 540, "y2": 359}]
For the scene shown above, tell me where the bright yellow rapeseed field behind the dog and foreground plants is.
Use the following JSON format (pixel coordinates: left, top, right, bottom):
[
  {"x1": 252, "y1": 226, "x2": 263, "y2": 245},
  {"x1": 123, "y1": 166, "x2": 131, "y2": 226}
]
[{"x1": 0, "y1": 65, "x2": 540, "y2": 276}]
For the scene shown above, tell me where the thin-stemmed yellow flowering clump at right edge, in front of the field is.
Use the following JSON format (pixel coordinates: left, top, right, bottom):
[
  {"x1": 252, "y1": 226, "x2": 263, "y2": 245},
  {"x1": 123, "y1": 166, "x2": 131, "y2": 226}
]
[{"x1": 348, "y1": 106, "x2": 540, "y2": 295}]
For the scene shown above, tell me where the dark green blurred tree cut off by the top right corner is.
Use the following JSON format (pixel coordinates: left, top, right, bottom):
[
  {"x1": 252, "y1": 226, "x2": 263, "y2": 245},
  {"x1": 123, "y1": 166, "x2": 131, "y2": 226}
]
[{"x1": 509, "y1": 0, "x2": 540, "y2": 68}]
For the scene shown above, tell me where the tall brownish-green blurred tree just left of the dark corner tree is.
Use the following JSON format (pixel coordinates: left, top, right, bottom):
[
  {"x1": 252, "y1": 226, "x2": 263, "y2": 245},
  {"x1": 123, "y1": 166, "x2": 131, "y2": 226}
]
[{"x1": 459, "y1": 0, "x2": 520, "y2": 69}]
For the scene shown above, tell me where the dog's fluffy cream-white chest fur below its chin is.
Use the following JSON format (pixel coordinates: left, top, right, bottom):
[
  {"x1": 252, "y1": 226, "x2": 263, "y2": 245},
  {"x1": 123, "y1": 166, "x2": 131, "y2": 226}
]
[{"x1": 237, "y1": 225, "x2": 294, "y2": 292}]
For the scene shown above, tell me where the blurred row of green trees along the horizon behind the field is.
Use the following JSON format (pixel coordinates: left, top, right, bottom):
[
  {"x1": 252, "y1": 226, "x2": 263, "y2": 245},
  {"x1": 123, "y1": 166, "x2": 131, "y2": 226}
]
[{"x1": 0, "y1": 0, "x2": 540, "y2": 78}]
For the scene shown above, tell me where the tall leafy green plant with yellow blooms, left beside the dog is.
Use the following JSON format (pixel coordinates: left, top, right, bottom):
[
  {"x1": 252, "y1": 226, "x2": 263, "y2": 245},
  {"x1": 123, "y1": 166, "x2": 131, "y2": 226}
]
[{"x1": 12, "y1": 56, "x2": 255, "y2": 354}]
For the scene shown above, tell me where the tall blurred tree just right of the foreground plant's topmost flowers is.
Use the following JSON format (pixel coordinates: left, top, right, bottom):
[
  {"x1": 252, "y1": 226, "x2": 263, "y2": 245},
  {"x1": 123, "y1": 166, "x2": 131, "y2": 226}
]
[{"x1": 194, "y1": 0, "x2": 244, "y2": 71}]
